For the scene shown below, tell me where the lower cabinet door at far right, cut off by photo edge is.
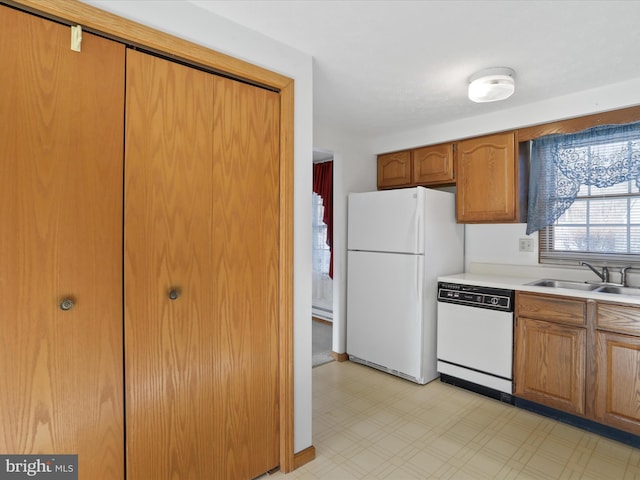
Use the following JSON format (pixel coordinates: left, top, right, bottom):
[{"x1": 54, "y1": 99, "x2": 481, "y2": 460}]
[{"x1": 595, "y1": 331, "x2": 640, "y2": 435}]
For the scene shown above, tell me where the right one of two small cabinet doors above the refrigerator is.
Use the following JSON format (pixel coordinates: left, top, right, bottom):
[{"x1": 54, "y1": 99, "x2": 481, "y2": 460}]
[{"x1": 411, "y1": 143, "x2": 455, "y2": 185}]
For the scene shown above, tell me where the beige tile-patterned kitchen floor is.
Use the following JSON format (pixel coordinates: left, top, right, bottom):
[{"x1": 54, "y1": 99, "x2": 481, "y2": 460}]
[{"x1": 265, "y1": 362, "x2": 640, "y2": 480}]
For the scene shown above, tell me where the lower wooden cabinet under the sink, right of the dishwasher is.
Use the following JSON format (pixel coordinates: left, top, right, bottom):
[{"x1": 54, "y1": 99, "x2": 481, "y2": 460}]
[{"x1": 514, "y1": 292, "x2": 640, "y2": 435}]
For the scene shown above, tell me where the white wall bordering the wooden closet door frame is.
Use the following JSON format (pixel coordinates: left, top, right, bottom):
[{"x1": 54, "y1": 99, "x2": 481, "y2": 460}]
[{"x1": 83, "y1": 0, "x2": 313, "y2": 452}]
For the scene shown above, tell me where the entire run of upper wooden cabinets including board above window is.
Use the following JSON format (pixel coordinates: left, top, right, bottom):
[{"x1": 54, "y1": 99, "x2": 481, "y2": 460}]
[{"x1": 378, "y1": 106, "x2": 640, "y2": 218}]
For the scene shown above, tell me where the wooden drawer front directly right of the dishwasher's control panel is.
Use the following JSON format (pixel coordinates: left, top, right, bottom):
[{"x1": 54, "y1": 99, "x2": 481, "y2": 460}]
[{"x1": 516, "y1": 292, "x2": 587, "y2": 325}]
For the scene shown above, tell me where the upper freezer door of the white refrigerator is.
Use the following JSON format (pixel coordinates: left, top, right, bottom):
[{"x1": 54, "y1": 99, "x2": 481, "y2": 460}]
[{"x1": 347, "y1": 187, "x2": 425, "y2": 254}]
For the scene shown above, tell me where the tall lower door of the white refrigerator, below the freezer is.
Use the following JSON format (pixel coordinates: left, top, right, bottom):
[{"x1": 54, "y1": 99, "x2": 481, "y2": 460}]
[{"x1": 347, "y1": 251, "x2": 424, "y2": 383}]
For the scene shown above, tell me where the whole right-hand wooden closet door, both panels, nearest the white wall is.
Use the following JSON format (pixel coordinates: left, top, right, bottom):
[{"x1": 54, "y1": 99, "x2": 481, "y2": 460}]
[{"x1": 125, "y1": 51, "x2": 279, "y2": 480}]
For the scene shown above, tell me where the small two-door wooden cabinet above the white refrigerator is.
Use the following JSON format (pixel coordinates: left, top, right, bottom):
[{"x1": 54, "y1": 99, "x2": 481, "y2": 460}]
[{"x1": 378, "y1": 143, "x2": 455, "y2": 190}]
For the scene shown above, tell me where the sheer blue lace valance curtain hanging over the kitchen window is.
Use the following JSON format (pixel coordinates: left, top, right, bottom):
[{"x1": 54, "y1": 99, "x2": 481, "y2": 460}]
[{"x1": 527, "y1": 122, "x2": 640, "y2": 234}]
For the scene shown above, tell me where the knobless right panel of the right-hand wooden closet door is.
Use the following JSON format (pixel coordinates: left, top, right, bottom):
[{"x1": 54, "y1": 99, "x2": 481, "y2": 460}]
[{"x1": 212, "y1": 77, "x2": 279, "y2": 478}]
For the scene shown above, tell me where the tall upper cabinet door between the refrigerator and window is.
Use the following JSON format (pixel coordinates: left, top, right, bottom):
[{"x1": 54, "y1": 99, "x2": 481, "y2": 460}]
[{"x1": 456, "y1": 133, "x2": 518, "y2": 223}]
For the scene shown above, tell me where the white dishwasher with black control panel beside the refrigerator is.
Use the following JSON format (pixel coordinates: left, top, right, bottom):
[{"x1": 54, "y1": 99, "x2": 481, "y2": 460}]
[{"x1": 437, "y1": 282, "x2": 515, "y2": 403}]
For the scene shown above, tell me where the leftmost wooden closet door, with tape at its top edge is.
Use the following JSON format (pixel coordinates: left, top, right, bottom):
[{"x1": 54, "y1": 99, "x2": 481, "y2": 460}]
[{"x1": 0, "y1": 6, "x2": 125, "y2": 480}]
